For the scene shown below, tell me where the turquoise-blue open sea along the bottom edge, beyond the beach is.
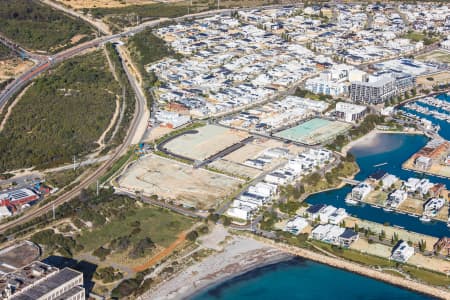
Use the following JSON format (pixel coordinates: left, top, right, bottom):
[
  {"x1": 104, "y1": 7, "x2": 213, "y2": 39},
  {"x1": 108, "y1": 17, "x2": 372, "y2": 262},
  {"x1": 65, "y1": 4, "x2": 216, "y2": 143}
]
[{"x1": 192, "y1": 258, "x2": 432, "y2": 300}]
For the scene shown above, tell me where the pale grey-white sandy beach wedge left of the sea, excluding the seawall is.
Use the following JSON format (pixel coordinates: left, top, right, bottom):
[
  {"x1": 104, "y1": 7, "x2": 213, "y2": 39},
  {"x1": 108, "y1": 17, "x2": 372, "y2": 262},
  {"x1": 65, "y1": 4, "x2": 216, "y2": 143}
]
[{"x1": 139, "y1": 236, "x2": 292, "y2": 300}]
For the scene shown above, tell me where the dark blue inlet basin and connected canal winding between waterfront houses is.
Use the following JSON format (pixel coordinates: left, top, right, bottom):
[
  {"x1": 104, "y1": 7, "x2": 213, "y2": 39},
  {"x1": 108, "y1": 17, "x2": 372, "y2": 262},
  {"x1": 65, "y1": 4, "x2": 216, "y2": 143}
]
[{"x1": 306, "y1": 133, "x2": 450, "y2": 237}]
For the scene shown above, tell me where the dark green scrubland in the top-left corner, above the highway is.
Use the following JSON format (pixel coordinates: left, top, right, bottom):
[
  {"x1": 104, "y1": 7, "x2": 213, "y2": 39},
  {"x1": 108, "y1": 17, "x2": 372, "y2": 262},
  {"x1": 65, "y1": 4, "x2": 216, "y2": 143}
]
[{"x1": 0, "y1": 0, "x2": 93, "y2": 52}]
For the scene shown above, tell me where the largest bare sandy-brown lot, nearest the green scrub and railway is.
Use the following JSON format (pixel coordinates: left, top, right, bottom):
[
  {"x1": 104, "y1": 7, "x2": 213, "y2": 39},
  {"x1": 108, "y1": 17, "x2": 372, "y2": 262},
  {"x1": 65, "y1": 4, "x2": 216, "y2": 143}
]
[{"x1": 119, "y1": 155, "x2": 241, "y2": 209}]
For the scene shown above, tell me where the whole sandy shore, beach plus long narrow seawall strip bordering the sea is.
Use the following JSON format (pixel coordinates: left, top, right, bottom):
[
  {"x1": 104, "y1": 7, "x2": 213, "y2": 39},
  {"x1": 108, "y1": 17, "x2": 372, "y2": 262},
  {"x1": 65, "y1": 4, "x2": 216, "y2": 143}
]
[{"x1": 146, "y1": 234, "x2": 450, "y2": 300}]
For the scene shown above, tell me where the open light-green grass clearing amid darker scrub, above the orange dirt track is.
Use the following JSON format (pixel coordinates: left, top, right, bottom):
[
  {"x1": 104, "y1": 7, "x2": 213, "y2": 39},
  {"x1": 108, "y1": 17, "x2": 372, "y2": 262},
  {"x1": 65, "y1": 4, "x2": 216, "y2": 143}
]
[{"x1": 77, "y1": 206, "x2": 194, "y2": 251}]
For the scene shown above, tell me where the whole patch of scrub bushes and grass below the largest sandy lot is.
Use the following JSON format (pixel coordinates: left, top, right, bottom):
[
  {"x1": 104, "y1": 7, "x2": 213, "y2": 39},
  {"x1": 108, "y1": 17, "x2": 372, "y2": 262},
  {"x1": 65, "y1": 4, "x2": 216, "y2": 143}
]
[{"x1": 16, "y1": 189, "x2": 193, "y2": 261}]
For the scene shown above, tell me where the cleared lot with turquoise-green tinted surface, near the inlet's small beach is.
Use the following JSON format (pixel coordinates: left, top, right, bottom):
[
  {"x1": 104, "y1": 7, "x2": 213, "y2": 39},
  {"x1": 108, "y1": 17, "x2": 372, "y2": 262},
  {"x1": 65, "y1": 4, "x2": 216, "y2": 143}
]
[{"x1": 275, "y1": 118, "x2": 351, "y2": 145}]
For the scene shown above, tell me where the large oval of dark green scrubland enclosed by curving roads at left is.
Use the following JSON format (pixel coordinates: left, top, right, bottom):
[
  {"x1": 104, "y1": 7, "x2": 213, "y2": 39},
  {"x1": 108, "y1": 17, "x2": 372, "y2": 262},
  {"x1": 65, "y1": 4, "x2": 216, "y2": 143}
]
[{"x1": 0, "y1": 51, "x2": 120, "y2": 172}]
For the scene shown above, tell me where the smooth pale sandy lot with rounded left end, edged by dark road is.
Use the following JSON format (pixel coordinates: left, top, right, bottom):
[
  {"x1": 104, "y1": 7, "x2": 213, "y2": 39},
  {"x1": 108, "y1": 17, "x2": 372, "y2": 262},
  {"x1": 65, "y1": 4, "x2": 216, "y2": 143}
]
[{"x1": 165, "y1": 125, "x2": 249, "y2": 160}]
